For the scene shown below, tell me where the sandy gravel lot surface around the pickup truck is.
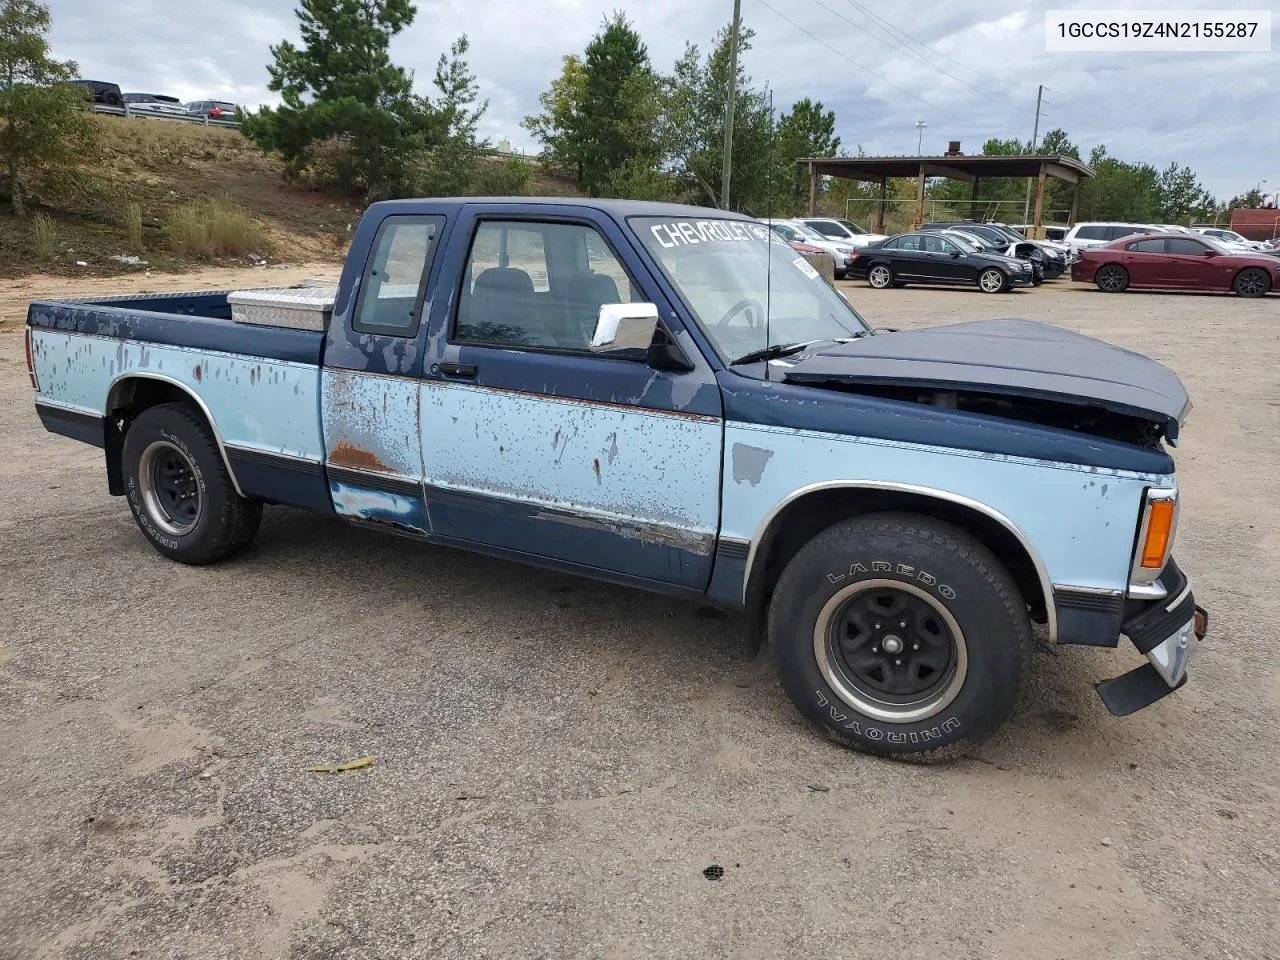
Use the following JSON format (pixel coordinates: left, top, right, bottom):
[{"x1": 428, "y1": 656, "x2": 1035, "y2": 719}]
[{"x1": 0, "y1": 271, "x2": 1280, "y2": 960}]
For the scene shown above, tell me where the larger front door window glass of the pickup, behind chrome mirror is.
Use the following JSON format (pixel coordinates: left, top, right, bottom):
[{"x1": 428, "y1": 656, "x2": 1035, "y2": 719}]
[{"x1": 453, "y1": 220, "x2": 637, "y2": 353}]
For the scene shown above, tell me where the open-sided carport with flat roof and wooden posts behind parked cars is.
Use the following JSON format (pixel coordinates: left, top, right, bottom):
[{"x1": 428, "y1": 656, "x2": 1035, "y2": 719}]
[{"x1": 799, "y1": 154, "x2": 1093, "y2": 237}]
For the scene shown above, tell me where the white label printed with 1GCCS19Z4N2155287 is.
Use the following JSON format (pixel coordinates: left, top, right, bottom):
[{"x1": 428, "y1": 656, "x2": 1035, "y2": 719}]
[{"x1": 1044, "y1": 9, "x2": 1271, "y2": 52}]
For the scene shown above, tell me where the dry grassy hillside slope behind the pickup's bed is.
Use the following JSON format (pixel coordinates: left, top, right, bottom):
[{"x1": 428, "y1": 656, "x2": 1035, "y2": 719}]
[{"x1": 0, "y1": 116, "x2": 572, "y2": 276}]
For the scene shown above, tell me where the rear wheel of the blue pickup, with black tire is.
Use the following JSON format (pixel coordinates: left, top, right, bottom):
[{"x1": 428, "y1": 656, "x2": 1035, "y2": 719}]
[{"x1": 122, "y1": 403, "x2": 262, "y2": 564}]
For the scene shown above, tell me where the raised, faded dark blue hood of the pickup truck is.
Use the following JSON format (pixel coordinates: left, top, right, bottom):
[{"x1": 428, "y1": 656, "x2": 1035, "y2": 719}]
[{"x1": 773, "y1": 320, "x2": 1192, "y2": 444}]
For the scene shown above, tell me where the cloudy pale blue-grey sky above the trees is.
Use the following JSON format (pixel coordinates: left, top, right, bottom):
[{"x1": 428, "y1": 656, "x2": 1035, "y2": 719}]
[{"x1": 50, "y1": 0, "x2": 1280, "y2": 198}]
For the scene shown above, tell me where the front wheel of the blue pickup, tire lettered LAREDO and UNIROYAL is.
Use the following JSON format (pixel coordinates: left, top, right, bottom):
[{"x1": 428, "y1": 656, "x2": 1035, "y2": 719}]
[{"x1": 768, "y1": 513, "x2": 1030, "y2": 759}]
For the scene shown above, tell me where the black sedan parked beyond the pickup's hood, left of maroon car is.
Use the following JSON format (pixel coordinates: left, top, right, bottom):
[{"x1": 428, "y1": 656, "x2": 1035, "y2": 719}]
[{"x1": 849, "y1": 230, "x2": 1034, "y2": 293}]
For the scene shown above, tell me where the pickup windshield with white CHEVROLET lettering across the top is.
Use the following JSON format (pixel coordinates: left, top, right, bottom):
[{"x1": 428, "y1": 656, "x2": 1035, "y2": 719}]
[{"x1": 628, "y1": 216, "x2": 870, "y2": 364}]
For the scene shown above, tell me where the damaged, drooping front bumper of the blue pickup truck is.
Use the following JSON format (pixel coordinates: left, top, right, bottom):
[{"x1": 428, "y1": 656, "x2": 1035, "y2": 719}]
[{"x1": 1097, "y1": 558, "x2": 1208, "y2": 717}]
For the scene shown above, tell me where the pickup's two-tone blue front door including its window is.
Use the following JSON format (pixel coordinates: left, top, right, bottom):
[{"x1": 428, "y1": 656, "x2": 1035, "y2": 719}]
[{"x1": 420, "y1": 205, "x2": 723, "y2": 590}]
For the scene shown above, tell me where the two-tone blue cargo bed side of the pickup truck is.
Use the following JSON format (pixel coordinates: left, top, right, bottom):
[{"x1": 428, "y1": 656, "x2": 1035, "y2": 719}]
[{"x1": 27, "y1": 291, "x2": 330, "y2": 511}]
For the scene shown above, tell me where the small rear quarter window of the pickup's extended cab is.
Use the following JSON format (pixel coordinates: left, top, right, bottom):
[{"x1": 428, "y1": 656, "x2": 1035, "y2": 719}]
[{"x1": 351, "y1": 216, "x2": 444, "y2": 337}]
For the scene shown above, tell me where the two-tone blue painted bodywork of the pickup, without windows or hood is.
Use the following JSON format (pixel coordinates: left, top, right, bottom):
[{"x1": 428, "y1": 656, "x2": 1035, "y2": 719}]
[{"x1": 29, "y1": 200, "x2": 1172, "y2": 655}]
